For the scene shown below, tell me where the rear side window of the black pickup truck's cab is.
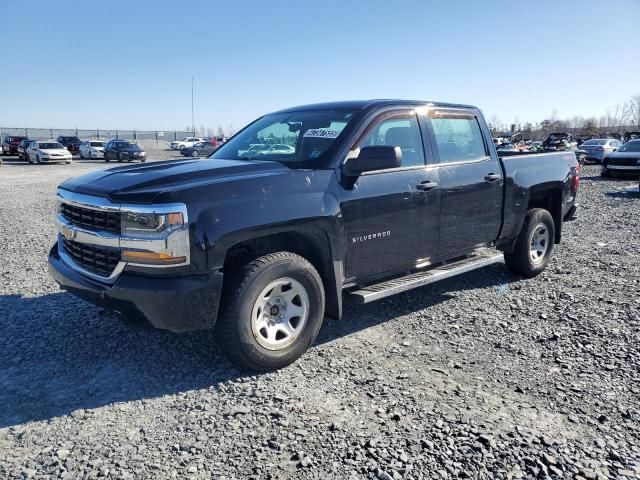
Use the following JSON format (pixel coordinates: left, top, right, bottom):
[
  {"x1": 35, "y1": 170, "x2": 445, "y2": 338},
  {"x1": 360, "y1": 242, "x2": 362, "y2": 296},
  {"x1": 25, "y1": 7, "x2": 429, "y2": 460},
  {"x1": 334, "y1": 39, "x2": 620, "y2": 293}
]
[{"x1": 431, "y1": 115, "x2": 487, "y2": 163}]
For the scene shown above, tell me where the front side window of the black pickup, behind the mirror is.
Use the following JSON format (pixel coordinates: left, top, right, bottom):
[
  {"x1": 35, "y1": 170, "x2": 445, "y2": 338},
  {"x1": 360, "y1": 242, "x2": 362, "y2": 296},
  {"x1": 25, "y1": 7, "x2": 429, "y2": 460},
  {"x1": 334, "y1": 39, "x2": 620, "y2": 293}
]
[{"x1": 358, "y1": 113, "x2": 424, "y2": 167}]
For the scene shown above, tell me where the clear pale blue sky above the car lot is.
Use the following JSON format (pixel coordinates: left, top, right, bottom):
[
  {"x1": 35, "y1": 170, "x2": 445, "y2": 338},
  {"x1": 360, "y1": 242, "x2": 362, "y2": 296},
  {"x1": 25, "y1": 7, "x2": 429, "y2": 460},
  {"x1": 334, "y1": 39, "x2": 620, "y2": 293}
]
[{"x1": 0, "y1": 0, "x2": 640, "y2": 130}]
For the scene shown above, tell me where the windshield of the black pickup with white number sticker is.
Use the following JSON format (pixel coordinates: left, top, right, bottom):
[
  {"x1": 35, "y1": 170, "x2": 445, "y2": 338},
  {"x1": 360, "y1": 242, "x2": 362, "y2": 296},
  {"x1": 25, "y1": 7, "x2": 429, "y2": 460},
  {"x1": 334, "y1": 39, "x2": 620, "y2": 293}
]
[{"x1": 210, "y1": 110, "x2": 354, "y2": 166}]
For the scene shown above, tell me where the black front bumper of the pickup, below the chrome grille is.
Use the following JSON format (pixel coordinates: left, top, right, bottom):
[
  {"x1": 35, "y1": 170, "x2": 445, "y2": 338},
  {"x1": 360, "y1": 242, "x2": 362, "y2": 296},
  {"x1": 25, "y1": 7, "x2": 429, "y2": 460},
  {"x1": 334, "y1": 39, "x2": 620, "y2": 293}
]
[{"x1": 49, "y1": 244, "x2": 222, "y2": 332}]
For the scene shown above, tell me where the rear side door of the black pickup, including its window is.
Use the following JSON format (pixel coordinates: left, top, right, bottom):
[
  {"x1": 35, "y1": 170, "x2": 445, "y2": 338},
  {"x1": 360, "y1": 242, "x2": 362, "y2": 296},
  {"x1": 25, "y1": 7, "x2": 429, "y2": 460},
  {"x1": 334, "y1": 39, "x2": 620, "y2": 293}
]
[{"x1": 427, "y1": 108, "x2": 504, "y2": 259}]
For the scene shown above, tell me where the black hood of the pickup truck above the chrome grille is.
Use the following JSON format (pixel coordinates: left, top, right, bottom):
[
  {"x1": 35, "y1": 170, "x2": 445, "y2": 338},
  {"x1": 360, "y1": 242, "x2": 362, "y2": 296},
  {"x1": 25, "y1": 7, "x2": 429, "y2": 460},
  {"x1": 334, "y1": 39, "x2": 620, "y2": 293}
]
[{"x1": 60, "y1": 159, "x2": 291, "y2": 203}]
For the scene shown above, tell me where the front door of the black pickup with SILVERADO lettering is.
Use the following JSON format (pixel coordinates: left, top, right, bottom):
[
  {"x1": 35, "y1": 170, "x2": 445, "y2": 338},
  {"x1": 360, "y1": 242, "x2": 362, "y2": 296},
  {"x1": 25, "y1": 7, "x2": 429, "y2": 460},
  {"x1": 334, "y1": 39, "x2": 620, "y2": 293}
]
[{"x1": 342, "y1": 109, "x2": 440, "y2": 282}]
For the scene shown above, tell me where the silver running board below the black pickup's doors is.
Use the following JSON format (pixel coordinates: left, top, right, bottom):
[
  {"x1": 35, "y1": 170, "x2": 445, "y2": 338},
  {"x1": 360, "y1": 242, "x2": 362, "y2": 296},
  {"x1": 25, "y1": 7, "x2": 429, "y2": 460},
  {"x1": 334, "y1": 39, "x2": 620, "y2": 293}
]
[{"x1": 348, "y1": 251, "x2": 504, "y2": 303}]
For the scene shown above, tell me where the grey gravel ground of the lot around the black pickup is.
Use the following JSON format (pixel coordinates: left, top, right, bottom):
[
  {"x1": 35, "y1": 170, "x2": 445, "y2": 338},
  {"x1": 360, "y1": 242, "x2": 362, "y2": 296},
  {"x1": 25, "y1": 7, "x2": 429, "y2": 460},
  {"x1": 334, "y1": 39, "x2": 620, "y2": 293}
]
[{"x1": 0, "y1": 162, "x2": 640, "y2": 480}]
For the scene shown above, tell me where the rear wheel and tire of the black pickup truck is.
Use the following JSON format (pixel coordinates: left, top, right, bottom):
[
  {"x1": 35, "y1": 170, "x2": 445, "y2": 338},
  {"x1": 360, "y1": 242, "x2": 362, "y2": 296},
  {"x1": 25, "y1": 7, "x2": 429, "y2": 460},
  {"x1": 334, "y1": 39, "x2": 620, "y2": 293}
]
[{"x1": 504, "y1": 208, "x2": 556, "y2": 278}]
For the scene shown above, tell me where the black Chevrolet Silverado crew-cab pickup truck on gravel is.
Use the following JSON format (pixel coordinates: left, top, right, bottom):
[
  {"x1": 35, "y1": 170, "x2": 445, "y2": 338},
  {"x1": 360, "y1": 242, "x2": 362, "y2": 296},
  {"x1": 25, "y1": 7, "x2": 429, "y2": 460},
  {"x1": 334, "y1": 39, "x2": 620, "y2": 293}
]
[{"x1": 49, "y1": 100, "x2": 579, "y2": 371}]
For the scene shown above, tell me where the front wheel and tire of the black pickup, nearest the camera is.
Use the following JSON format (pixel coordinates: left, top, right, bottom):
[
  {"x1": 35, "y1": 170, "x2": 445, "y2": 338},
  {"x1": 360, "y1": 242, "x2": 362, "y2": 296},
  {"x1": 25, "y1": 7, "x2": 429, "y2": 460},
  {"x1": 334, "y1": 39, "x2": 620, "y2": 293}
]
[{"x1": 216, "y1": 252, "x2": 325, "y2": 372}]
